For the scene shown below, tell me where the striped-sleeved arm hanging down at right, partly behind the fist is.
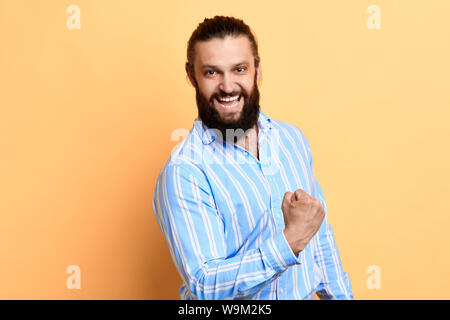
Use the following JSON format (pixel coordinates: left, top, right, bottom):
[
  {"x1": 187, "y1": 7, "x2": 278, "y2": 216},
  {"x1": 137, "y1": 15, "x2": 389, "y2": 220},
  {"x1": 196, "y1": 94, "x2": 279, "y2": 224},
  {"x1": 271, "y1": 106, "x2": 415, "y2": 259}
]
[{"x1": 300, "y1": 127, "x2": 353, "y2": 299}]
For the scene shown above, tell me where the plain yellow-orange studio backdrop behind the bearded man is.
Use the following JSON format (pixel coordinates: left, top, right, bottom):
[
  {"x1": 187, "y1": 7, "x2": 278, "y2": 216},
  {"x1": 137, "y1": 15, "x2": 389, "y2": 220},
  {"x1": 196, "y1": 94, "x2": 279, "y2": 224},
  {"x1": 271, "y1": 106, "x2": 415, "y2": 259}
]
[{"x1": 0, "y1": 0, "x2": 450, "y2": 299}]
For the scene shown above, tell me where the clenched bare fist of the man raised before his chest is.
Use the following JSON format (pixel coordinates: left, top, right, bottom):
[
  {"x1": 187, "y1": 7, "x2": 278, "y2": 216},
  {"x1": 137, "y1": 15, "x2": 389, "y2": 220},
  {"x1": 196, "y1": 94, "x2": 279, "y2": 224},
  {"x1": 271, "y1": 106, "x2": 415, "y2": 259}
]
[{"x1": 281, "y1": 189, "x2": 325, "y2": 254}]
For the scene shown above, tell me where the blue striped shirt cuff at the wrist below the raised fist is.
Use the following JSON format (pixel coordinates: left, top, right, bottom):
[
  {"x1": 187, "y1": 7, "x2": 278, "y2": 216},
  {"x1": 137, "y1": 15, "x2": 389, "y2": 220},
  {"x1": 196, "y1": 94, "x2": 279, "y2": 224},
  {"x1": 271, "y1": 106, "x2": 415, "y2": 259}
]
[{"x1": 261, "y1": 232, "x2": 303, "y2": 273}]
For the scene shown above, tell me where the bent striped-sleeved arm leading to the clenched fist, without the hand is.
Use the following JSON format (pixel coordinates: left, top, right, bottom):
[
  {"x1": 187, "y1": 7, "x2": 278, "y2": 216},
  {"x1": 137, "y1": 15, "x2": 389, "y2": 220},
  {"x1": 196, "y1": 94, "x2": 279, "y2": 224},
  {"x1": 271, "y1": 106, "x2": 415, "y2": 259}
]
[{"x1": 153, "y1": 162, "x2": 303, "y2": 299}]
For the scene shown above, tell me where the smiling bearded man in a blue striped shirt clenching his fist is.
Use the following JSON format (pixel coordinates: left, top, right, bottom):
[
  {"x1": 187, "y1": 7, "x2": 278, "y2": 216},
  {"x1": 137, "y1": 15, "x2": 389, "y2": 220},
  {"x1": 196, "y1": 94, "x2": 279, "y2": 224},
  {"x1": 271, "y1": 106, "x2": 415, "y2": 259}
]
[{"x1": 153, "y1": 16, "x2": 353, "y2": 299}]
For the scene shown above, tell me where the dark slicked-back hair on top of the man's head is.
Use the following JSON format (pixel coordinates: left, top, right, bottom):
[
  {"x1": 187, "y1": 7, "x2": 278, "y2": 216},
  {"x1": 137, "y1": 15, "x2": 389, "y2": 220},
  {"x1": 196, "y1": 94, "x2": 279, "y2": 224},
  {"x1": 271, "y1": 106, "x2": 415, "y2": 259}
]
[{"x1": 186, "y1": 16, "x2": 260, "y2": 75}]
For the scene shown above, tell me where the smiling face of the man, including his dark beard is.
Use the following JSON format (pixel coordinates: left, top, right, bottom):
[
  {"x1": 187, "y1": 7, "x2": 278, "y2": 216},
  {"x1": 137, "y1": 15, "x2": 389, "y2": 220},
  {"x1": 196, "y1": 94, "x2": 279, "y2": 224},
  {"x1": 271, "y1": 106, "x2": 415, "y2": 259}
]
[{"x1": 190, "y1": 36, "x2": 259, "y2": 137}]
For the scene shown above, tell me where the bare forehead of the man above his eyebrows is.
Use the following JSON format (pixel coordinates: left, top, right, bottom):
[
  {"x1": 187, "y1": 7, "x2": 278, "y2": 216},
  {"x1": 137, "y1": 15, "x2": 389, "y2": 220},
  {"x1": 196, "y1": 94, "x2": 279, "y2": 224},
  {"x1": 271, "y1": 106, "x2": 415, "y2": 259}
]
[{"x1": 194, "y1": 36, "x2": 253, "y2": 67}]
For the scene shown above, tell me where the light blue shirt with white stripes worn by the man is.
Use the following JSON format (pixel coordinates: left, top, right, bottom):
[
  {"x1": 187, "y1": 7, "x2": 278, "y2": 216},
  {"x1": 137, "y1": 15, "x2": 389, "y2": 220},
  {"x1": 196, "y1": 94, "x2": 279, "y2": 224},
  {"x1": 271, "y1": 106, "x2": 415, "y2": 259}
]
[{"x1": 153, "y1": 111, "x2": 353, "y2": 300}]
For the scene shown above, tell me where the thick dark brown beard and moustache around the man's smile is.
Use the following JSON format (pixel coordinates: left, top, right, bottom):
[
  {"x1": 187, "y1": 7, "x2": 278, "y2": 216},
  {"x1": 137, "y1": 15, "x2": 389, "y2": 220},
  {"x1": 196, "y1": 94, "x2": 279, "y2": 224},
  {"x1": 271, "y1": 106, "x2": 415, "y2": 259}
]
[{"x1": 195, "y1": 77, "x2": 260, "y2": 143}]
